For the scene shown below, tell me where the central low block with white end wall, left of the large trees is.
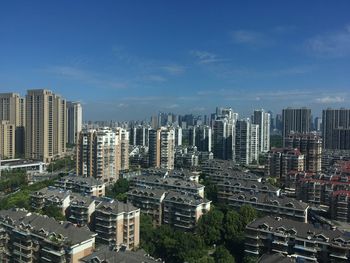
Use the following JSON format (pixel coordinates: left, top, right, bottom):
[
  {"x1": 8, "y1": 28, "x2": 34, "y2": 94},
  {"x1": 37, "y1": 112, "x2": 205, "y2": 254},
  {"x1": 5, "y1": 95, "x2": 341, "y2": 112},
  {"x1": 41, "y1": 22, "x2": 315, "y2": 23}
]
[{"x1": 163, "y1": 191, "x2": 211, "y2": 230}]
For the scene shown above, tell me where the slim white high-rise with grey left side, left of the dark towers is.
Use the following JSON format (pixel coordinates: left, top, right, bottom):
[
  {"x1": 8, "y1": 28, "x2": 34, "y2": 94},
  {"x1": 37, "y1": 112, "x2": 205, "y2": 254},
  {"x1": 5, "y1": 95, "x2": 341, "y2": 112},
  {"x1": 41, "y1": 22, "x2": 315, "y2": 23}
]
[{"x1": 253, "y1": 109, "x2": 271, "y2": 153}]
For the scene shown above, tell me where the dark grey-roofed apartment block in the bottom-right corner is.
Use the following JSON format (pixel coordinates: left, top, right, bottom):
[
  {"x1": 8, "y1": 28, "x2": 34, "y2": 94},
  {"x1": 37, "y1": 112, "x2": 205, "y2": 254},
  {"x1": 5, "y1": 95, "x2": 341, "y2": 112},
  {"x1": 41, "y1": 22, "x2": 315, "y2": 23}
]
[{"x1": 245, "y1": 216, "x2": 350, "y2": 263}]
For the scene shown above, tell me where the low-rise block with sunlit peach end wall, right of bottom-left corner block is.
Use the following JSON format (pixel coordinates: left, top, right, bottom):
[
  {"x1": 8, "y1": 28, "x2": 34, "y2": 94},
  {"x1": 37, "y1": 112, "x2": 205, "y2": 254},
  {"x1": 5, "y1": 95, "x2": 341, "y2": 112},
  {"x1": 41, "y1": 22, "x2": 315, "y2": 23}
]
[{"x1": 94, "y1": 201, "x2": 140, "y2": 250}]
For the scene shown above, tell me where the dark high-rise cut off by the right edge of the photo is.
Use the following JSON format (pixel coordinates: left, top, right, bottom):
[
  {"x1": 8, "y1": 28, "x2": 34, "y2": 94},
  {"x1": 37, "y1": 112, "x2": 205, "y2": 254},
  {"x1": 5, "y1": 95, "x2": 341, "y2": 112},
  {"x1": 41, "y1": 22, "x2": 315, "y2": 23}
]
[{"x1": 322, "y1": 109, "x2": 350, "y2": 150}]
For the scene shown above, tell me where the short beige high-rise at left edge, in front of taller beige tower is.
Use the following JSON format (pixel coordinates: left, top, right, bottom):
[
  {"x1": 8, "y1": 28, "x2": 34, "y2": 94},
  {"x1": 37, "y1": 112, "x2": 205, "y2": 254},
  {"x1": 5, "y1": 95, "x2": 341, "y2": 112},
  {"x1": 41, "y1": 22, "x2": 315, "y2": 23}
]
[{"x1": 0, "y1": 121, "x2": 16, "y2": 159}]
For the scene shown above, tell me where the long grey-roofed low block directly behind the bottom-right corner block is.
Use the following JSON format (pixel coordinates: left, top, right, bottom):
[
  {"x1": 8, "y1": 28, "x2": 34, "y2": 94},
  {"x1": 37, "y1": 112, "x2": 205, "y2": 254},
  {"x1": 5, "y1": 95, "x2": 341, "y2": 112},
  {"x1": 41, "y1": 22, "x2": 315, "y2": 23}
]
[{"x1": 224, "y1": 192, "x2": 309, "y2": 222}]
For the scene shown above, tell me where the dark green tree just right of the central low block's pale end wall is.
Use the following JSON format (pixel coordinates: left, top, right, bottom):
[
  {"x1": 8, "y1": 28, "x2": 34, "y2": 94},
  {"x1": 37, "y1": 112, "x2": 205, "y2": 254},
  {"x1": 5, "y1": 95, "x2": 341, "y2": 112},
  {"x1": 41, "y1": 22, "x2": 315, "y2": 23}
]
[{"x1": 197, "y1": 209, "x2": 224, "y2": 245}]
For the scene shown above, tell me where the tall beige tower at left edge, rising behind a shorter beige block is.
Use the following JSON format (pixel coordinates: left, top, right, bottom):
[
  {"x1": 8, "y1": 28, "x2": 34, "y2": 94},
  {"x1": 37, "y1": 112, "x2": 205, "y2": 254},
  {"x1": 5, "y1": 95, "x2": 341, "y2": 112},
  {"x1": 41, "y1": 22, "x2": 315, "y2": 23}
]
[{"x1": 0, "y1": 93, "x2": 25, "y2": 156}]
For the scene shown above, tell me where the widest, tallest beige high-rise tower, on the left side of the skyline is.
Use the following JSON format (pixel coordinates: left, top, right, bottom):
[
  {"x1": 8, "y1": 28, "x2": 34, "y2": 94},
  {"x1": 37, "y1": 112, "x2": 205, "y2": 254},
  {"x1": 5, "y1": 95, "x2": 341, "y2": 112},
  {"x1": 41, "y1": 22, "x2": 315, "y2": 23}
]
[{"x1": 25, "y1": 89, "x2": 67, "y2": 162}]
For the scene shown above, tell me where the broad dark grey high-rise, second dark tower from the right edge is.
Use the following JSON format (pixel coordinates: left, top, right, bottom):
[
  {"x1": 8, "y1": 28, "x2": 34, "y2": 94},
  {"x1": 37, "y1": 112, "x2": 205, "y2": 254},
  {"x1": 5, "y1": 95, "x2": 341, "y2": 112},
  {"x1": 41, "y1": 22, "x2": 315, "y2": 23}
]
[{"x1": 282, "y1": 108, "x2": 311, "y2": 143}]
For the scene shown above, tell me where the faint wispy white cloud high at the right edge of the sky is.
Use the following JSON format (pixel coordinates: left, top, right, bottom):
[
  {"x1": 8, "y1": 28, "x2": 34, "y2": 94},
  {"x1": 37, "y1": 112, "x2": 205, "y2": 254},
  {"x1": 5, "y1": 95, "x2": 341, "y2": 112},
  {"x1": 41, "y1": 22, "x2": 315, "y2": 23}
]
[{"x1": 306, "y1": 25, "x2": 350, "y2": 57}]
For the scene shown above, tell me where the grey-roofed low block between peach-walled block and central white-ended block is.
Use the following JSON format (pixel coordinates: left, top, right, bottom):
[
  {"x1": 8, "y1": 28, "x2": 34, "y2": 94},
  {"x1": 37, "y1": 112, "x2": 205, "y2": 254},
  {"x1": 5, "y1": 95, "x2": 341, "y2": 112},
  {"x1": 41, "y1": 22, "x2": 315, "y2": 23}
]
[{"x1": 127, "y1": 187, "x2": 166, "y2": 226}]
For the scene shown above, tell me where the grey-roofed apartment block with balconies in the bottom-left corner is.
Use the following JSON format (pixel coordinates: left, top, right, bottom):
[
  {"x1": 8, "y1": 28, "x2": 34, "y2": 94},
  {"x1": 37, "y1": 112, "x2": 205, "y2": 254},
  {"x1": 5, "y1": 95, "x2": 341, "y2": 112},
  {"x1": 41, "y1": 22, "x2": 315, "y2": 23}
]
[{"x1": 0, "y1": 209, "x2": 96, "y2": 263}]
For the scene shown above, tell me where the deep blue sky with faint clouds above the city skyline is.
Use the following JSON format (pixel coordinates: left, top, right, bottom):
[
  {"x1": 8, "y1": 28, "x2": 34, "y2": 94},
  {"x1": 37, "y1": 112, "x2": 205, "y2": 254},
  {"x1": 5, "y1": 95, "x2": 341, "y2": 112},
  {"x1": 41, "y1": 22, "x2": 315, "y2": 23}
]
[{"x1": 0, "y1": 0, "x2": 350, "y2": 120}]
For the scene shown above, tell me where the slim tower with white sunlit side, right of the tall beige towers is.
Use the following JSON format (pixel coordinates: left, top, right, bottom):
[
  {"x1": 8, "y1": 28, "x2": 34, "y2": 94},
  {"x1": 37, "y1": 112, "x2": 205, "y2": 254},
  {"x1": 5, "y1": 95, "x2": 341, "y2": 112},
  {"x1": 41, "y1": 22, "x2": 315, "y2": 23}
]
[{"x1": 67, "y1": 101, "x2": 83, "y2": 144}]
